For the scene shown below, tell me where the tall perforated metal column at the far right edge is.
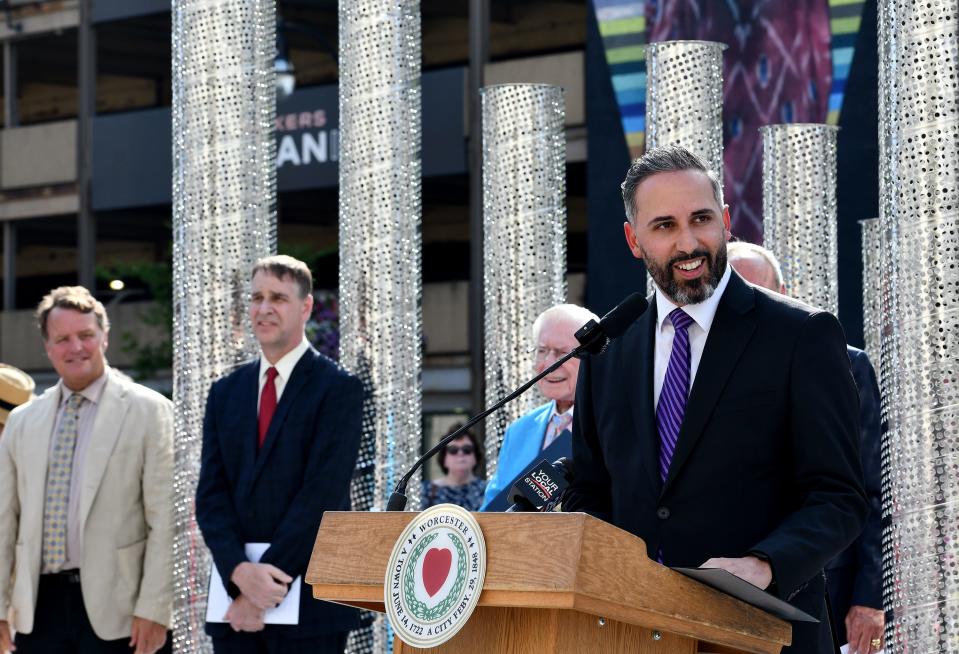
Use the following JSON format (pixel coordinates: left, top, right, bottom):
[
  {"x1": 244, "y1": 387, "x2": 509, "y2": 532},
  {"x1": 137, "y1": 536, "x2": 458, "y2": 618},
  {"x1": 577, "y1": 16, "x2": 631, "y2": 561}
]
[{"x1": 879, "y1": 0, "x2": 959, "y2": 654}]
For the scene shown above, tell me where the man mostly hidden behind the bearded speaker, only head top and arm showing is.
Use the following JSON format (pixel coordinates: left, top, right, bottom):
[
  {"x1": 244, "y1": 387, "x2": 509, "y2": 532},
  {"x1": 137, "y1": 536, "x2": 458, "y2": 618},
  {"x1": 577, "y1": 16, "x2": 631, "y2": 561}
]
[{"x1": 728, "y1": 241, "x2": 885, "y2": 654}]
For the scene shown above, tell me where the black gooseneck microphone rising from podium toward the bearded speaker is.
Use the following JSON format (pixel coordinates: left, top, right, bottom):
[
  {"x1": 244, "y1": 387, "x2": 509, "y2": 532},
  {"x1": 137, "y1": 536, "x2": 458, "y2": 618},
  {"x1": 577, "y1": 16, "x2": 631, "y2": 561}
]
[{"x1": 386, "y1": 293, "x2": 649, "y2": 511}]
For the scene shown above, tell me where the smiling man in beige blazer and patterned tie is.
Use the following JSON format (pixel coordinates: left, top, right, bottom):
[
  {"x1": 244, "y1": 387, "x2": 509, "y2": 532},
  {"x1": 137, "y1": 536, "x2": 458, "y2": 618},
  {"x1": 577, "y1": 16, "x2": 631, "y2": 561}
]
[{"x1": 0, "y1": 287, "x2": 173, "y2": 654}]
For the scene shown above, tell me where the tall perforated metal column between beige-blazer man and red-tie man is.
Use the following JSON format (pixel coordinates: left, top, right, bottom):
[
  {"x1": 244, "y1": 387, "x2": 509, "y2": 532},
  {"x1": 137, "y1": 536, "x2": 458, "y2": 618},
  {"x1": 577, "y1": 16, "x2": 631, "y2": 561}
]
[{"x1": 172, "y1": 0, "x2": 276, "y2": 654}]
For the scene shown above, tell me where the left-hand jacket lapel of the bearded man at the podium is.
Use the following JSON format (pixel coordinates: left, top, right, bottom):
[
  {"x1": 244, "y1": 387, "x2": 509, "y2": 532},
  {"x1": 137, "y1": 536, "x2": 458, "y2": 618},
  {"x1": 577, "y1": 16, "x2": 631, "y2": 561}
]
[{"x1": 620, "y1": 297, "x2": 661, "y2": 493}]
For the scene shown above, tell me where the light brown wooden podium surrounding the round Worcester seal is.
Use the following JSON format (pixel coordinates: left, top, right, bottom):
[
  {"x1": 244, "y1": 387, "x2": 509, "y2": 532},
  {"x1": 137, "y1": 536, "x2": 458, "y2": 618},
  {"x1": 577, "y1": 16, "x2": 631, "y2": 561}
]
[{"x1": 306, "y1": 511, "x2": 791, "y2": 654}]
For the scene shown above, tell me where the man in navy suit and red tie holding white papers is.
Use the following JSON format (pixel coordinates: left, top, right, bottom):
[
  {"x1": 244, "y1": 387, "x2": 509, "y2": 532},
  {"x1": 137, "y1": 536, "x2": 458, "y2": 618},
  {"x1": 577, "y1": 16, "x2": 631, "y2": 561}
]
[{"x1": 196, "y1": 256, "x2": 362, "y2": 654}]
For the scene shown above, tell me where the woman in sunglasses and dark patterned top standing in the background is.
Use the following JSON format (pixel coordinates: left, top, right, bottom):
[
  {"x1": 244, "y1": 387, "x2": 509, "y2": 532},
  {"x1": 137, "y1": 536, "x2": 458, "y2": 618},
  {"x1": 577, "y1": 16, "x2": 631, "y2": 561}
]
[{"x1": 421, "y1": 423, "x2": 486, "y2": 511}]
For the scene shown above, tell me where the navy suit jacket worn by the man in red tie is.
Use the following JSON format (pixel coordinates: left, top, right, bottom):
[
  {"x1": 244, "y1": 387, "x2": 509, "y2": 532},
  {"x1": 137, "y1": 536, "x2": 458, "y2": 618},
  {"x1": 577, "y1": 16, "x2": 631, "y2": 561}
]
[{"x1": 196, "y1": 348, "x2": 362, "y2": 637}]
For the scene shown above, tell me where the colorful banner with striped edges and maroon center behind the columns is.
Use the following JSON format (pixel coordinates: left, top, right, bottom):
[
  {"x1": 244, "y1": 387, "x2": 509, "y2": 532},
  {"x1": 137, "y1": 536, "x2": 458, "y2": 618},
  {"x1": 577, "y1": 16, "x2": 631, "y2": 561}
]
[{"x1": 593, "y1": 0, "x2": 864, "y2": 242}]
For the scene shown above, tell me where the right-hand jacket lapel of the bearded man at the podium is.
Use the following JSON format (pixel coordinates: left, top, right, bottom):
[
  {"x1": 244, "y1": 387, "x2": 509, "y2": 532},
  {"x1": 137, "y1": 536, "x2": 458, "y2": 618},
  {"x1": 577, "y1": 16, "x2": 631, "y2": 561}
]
[{"x1": 663, "y1": 272, "x2": 756, "y2": 492}]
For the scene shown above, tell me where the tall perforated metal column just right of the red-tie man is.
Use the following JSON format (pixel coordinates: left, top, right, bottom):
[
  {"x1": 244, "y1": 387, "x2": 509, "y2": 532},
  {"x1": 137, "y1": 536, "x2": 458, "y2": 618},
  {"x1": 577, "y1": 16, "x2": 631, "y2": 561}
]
[{"x1": 339, "y1": 0, "x2": 422, "y2": 652}]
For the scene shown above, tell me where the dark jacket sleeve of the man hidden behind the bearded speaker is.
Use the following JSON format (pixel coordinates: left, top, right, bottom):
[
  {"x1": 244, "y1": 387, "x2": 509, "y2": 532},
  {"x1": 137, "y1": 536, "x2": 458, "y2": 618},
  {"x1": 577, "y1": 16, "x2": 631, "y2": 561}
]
[{"x1": 826, "y1": 347, "x2": 882, "y2": 643}]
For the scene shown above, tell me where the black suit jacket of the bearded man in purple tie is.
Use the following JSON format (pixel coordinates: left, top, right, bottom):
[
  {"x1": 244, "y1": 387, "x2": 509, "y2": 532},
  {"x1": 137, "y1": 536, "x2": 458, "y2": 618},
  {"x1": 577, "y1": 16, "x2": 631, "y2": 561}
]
[{"x1": 563, "y1": 272, "x2": 867, "y2": 654}]
